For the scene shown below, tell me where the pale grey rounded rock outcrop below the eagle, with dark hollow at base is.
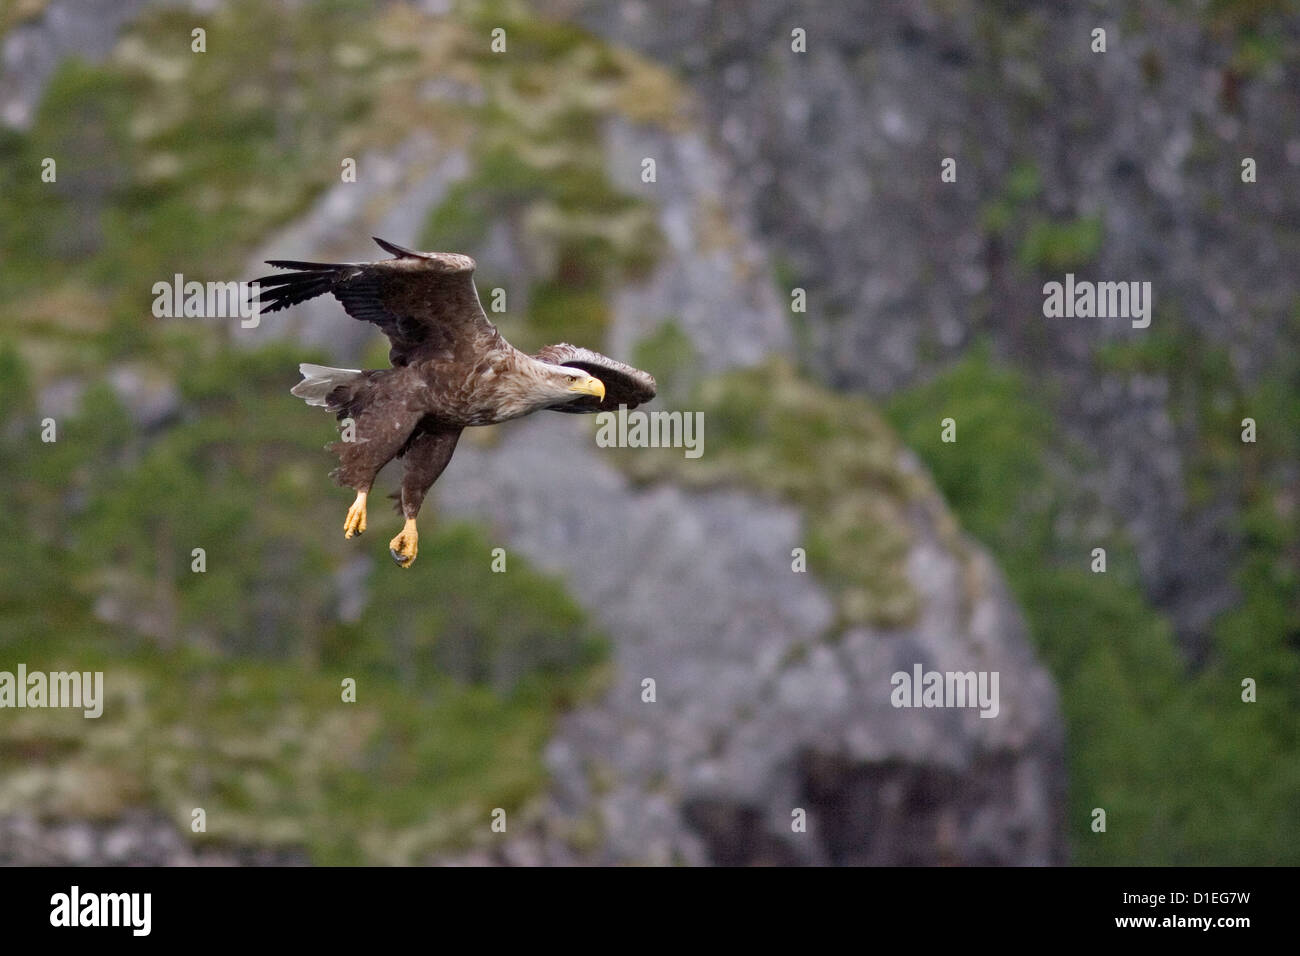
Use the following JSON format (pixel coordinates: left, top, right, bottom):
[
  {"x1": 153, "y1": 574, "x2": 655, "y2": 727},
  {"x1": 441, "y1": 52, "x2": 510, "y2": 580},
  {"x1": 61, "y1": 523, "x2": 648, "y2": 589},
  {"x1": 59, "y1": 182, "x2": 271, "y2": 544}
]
[{"x1": 439, "y1": 419, "x2": 1065, "y2": 865}]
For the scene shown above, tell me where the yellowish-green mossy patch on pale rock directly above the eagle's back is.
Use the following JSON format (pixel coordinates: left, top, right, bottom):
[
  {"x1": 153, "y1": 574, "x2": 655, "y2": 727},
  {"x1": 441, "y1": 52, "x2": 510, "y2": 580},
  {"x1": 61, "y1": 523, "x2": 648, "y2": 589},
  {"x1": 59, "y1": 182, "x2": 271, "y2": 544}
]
[{"x1": 421, "y1": 3, "x2": 677, "y2": 351}]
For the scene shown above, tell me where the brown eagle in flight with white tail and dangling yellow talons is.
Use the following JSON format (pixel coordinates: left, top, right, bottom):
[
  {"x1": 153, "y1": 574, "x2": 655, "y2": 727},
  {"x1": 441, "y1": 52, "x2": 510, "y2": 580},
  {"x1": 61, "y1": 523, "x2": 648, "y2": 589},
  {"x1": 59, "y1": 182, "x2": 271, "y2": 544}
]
[{"x1": 256, "y1": 238, "x2": 655, "y2": 567}]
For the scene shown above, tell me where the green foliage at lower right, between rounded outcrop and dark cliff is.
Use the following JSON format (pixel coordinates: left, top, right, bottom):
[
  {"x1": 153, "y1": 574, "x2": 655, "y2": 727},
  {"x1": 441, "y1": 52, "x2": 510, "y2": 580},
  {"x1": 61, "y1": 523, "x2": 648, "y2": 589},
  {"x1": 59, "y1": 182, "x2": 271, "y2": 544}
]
[{"x1": 887, "y1": 343, "x2": 1300, "y2": 865}]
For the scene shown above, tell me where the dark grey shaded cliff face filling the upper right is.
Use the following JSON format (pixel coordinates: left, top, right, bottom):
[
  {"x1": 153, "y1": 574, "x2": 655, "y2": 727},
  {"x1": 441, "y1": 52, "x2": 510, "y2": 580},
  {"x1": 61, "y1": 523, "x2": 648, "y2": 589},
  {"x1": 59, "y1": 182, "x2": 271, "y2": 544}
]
[{"x1": 542, "y1": 0, "x2": 1300, "y2": 658}]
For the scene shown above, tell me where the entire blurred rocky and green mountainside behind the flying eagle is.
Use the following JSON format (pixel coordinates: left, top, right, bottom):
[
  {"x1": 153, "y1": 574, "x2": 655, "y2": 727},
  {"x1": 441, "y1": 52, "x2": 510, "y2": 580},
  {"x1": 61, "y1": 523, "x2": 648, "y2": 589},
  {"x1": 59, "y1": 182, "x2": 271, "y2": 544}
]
[{"x1": 0, "y1": 0, "x2": 1300, "y2": 865}]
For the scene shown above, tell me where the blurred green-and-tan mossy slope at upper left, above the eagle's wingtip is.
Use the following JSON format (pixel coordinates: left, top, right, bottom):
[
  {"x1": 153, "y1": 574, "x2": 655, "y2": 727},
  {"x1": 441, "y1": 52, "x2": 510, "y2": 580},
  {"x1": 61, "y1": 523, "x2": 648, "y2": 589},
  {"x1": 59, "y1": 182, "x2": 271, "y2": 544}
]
[{"x1": 0, "y1": 0, "x2": 377, "y2": 347}]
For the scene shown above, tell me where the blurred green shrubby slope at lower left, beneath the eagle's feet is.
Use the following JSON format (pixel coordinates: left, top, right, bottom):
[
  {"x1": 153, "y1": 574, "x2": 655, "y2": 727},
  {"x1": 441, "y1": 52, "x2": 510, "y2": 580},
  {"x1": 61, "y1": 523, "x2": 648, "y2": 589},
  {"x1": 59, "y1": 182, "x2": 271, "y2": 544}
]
[{"x1": 0, "y1": 347, "x2": 606, "y2": 862}]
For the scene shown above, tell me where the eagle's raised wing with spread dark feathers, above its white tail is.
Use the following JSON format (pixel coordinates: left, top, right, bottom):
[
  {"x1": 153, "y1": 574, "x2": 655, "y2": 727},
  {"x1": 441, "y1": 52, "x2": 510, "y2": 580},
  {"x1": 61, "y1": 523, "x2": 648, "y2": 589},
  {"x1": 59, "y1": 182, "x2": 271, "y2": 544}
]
[{"x1": 256, "y1": 237, "x2": 499, "y2": 365}]
